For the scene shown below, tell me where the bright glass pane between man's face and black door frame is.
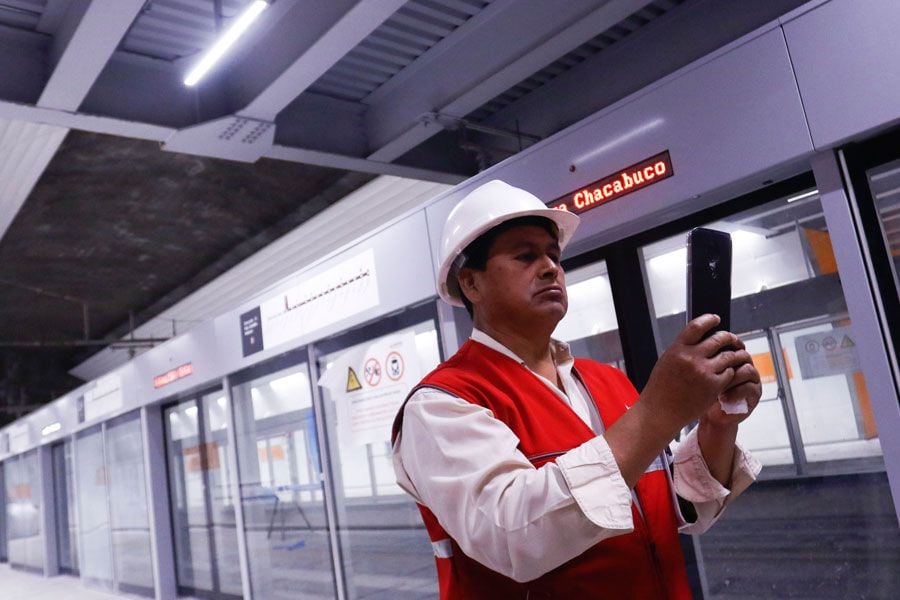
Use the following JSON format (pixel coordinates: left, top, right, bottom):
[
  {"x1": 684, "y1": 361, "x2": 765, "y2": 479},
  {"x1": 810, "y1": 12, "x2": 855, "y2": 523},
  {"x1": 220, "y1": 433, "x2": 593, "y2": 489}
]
[{"x1": 553, "y1": 261, "x2": 625, "y2": 370}]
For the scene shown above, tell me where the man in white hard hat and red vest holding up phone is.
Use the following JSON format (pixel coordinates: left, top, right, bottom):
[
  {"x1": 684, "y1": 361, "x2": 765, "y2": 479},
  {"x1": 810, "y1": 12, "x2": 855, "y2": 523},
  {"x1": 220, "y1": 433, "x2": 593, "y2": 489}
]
[{"x1": 394, "y1": 181, "x2": 761, "y2": 600}]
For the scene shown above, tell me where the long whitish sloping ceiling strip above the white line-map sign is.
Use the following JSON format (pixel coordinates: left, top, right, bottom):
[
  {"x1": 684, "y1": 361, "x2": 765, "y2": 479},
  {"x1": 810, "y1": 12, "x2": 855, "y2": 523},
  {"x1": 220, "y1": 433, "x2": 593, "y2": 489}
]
[{"x1": 70, "y1": 175, "x2": 451, "y2": 380}]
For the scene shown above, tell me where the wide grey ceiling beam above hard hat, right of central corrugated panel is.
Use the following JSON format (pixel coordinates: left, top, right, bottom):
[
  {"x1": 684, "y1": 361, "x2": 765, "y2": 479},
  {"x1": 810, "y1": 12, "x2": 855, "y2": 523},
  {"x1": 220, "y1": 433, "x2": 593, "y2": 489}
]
[{"x1": 366, "y1": 0, "x2": 650, "y2": 162}]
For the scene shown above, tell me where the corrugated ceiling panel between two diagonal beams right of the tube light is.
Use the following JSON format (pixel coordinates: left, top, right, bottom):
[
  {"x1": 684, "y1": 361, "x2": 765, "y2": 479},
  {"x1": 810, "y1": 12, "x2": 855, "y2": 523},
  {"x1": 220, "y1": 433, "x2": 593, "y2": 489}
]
[{"x1": 310, "y1": 0, "x2": 490, "y2": 102}]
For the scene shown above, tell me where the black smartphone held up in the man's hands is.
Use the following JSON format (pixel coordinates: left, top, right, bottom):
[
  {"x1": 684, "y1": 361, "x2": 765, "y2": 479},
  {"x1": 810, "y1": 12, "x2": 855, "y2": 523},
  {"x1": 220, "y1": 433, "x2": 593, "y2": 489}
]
[{"x1": 687, "y1": 227, "x2": 731, "y2": 337}]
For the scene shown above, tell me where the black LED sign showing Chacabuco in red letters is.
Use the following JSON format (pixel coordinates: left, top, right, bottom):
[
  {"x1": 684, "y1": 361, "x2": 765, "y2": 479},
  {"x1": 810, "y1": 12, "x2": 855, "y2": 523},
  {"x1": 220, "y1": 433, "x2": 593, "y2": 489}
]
[{"x1": 548, "y1": 150, "x2": 675, "y2": 213}]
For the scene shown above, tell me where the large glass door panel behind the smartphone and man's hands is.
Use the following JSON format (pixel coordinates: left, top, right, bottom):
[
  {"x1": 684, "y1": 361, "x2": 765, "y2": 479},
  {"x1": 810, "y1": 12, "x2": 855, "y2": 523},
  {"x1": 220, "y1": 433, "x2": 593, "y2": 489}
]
[{"x1": 643, "y1": 185, "x2": 900, "y2": 599}]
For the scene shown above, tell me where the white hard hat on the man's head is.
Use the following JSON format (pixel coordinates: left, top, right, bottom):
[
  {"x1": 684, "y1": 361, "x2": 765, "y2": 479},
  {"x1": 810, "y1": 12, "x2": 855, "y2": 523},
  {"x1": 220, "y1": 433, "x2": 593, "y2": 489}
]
[{"x1": 437, "y1": 179, "x2": 581, "y2": 306}]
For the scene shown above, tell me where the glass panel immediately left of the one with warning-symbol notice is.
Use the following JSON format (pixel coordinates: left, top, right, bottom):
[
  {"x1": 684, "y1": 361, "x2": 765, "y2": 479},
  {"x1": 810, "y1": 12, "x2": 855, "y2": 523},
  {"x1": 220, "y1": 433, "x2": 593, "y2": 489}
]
[{"x1": 234, "y1": 364, "x2": 335, "y2": 599}]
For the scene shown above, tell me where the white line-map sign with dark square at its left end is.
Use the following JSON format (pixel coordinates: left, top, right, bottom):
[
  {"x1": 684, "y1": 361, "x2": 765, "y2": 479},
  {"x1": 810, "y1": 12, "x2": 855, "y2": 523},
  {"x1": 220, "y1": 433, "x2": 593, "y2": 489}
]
[{"x1": 240, "y1": 248, "x2": 379, "y2": 356}]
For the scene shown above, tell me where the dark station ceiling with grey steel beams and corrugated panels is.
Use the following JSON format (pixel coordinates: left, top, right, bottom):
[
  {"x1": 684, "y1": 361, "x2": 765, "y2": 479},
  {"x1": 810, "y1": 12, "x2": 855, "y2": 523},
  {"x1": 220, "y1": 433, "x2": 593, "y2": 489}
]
[{"x1": 0, "y1": 0, "x2": 801, "y2": 420}]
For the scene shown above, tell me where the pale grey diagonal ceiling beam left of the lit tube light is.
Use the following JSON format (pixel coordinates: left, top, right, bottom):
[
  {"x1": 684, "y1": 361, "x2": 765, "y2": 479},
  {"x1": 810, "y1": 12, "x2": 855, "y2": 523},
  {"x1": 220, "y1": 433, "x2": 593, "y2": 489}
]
[{"x1": 37, "y1": 0, "x2": 144, "y2": 110}]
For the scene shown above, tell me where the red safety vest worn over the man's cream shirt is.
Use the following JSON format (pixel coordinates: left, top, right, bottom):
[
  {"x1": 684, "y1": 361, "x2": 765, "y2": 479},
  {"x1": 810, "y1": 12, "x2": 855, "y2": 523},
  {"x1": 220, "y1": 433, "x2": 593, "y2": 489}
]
[{"x1": 393, "y1": 340, "x2": 691, "y2": 600}]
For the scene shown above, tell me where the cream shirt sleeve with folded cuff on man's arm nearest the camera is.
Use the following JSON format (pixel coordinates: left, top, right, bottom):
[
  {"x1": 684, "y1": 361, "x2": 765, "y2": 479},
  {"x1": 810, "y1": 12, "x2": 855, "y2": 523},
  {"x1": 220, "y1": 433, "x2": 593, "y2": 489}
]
[{"x1": 394, "y1": 388, "x2": 633, "y2": 581}]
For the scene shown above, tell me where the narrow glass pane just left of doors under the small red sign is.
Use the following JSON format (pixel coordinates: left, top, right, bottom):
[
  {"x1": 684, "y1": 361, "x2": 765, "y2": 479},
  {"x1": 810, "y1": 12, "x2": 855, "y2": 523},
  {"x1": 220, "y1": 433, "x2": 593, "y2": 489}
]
[{"x1": 106, "y1": 413, "x2": 153, "y2": 596}]
